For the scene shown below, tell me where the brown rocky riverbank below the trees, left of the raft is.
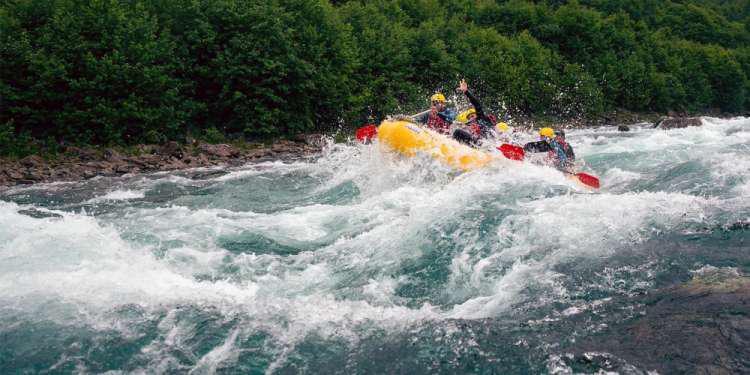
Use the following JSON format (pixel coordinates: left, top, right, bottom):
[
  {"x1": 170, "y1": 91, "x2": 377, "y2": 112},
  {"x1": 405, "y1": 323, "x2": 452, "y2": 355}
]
[{"x1": 0, "y1": 135, "x2": 324, "y2": 187}]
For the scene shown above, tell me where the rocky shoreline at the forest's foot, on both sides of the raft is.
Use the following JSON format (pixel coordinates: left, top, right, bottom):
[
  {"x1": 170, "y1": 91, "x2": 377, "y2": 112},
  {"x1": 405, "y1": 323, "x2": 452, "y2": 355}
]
[{"x1": 0, "y1": 112, "x2": 708, "y2": 189}]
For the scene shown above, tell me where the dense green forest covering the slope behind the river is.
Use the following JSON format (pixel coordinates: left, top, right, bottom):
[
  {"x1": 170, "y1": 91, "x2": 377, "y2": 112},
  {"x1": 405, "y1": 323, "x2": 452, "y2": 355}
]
[{"x1": 0, "y1": 0, "x2": 750, "y2": 155}]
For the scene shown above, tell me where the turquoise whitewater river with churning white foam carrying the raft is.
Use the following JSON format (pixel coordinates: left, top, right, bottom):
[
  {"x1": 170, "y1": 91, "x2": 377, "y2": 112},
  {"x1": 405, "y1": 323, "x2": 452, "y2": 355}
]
[{"x1": 0, "y1": 118, "x2": 750, "y2": 374}]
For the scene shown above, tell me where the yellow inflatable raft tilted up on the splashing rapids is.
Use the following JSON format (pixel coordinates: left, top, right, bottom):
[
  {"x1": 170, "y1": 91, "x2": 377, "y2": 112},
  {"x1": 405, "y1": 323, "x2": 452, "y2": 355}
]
[{"x1": 378, "y1": 121, "x2": 494, "y2": 171}]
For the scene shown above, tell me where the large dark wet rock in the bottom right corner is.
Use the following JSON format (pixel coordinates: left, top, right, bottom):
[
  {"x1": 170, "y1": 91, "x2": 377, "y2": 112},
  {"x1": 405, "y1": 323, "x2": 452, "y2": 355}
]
[{"x1": 573, "y1": 269, "x2": 750, "y2": 374}]
